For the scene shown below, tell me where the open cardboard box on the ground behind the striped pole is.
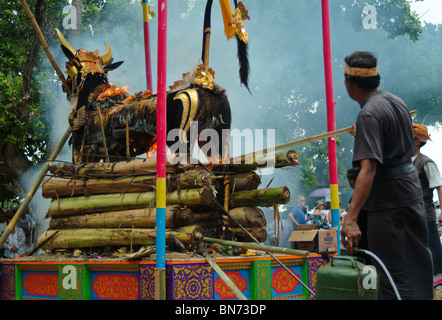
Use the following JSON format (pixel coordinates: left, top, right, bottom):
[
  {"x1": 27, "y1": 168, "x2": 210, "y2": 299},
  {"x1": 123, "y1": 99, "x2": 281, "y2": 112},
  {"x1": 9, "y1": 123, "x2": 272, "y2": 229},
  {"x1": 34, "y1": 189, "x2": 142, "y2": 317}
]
[{"x1": 289, "y1": 224, "x2": 338, "y2": 253}]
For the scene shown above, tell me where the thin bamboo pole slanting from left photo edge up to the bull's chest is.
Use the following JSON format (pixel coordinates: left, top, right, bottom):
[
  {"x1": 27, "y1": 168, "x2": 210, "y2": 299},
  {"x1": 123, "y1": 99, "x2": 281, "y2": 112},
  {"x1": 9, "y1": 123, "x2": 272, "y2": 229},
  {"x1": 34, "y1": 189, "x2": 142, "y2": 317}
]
[{"x1": 0, "y1": 127, "x2": 72, "y2": 248}]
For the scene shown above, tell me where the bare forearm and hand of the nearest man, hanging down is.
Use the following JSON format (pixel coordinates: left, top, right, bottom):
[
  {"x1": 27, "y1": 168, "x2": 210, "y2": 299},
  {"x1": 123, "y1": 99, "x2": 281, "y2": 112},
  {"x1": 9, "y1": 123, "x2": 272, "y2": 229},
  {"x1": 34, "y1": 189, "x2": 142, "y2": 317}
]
[{"x1": 341, "y1": 159, "x2": 377, "y2": 254}]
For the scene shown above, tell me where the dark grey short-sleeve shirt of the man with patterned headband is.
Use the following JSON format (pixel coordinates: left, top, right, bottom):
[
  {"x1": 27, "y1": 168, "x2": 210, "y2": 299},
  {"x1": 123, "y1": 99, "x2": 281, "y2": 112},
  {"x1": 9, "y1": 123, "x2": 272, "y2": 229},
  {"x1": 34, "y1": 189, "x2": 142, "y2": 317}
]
[{"x1": 353, "y1": 91, "x2": 422, "y2": 211}]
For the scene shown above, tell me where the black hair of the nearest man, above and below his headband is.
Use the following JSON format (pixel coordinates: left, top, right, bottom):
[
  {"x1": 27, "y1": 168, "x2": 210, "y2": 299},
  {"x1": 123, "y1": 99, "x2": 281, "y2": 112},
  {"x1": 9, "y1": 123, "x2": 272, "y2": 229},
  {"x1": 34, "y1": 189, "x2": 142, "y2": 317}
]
[{"x1": 344, "y1": 51, "x2": 381, "y2": 90}]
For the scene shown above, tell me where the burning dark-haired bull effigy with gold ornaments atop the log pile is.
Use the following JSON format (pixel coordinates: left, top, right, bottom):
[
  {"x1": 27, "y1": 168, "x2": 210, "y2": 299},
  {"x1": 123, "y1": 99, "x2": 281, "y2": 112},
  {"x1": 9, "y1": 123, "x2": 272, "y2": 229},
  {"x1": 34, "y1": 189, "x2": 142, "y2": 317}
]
[{"x1": 57, "y1": 30, "x2": 231, "y2": 163}]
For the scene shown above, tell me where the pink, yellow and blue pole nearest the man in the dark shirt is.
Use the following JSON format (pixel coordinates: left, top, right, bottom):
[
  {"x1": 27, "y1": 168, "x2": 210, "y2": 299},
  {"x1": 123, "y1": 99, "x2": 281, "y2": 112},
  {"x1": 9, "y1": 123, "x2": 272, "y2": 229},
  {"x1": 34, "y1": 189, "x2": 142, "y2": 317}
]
[{"x1": 321, "y1": 0, "x2": 340, "y2": 245}]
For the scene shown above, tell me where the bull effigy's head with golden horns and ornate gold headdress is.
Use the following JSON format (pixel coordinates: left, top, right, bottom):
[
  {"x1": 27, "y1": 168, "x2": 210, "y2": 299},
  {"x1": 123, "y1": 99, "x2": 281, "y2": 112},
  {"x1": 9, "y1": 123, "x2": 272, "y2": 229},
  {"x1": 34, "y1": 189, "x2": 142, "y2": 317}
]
[{"x1": 55, "y1": 29, "x2": 123, "y2": 94}]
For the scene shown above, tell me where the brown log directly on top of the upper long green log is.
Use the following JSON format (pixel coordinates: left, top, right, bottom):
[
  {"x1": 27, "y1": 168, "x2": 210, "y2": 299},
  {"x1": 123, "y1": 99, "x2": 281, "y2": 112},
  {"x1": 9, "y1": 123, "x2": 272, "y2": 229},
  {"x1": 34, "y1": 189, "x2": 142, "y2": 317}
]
[{"x1": 42, "y1": 170, "x2": 213, "y2": 199}]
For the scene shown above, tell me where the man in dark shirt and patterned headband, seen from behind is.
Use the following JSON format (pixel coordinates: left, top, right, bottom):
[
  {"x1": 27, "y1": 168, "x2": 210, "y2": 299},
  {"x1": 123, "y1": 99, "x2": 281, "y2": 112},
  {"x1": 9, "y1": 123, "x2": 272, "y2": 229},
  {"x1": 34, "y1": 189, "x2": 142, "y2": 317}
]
[{"x1": 341, "y1": 52, "x2": 433, "y2": 299}]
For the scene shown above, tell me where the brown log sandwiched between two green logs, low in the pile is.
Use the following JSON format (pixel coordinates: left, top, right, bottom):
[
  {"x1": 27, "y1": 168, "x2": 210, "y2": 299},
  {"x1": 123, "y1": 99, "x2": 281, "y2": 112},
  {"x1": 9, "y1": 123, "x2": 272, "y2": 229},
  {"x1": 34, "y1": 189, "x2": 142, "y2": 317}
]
[{"x1": 49, "y1": 205, "x2": 192, "y2": 229}]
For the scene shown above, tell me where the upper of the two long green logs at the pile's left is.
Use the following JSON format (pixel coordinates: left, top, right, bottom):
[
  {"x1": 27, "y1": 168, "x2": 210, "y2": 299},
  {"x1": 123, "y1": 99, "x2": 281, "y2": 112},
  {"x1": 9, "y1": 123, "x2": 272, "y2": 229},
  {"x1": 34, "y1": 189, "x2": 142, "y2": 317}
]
[{"x1": 47, "y1": 188, "x2": 213, "y2": 217}]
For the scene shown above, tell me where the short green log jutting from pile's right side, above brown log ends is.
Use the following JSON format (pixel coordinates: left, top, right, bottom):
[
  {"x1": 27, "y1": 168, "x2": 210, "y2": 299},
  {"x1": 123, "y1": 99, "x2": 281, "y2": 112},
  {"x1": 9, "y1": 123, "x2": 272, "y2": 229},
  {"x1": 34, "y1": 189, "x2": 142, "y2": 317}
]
[{"x1": 230, "y1": 187, "x2": 290, "y2": 208}]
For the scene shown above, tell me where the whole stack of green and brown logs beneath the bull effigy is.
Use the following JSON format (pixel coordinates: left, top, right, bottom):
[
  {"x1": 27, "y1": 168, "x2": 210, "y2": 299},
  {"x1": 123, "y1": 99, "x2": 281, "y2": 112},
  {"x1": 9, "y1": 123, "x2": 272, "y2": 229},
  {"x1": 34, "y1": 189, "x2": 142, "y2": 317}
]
[{"x1": 37, "y1": 150, "x2": 299, "y2": 249}]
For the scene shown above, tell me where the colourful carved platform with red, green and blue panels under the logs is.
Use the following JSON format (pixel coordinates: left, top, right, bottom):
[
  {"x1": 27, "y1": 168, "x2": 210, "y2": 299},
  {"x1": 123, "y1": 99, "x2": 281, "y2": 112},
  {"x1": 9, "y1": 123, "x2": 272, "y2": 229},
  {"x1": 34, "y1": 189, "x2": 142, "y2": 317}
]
[{"x1": 0, "y1": 254, "x2": 324, "y2": 300}]
